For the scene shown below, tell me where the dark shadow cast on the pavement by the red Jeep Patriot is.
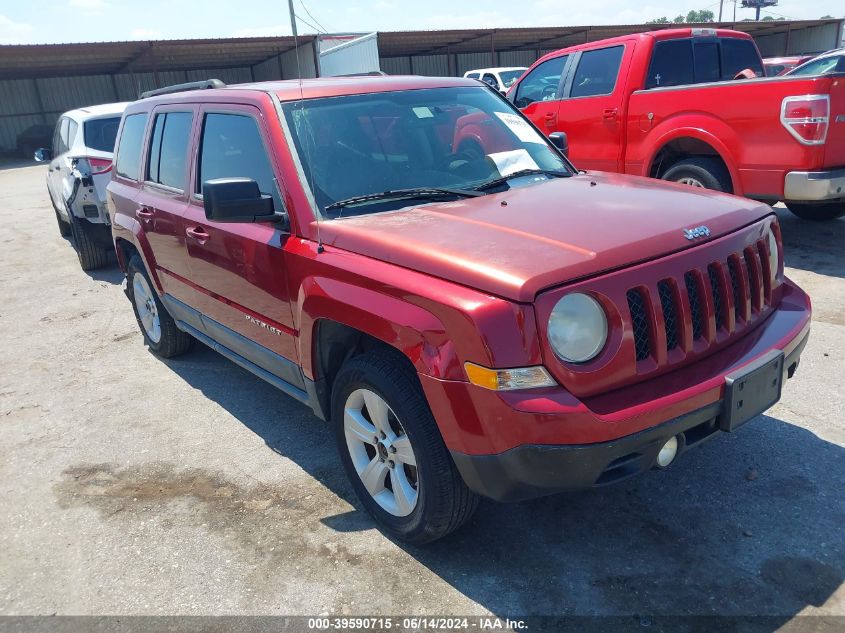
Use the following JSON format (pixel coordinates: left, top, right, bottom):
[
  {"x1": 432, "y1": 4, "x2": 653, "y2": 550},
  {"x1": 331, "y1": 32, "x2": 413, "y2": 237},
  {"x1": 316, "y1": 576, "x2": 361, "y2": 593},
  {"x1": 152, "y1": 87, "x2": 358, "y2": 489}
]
[{"x1": 147, "y1": 346, "x2": 845, "y2": 630}]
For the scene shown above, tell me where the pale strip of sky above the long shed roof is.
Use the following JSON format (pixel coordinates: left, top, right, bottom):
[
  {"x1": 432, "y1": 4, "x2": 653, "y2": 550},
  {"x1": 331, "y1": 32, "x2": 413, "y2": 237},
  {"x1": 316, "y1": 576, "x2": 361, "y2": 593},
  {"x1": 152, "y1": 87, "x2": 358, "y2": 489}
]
[{"x1": 0, "y1": 0, "x2": 845, "y2": 44}]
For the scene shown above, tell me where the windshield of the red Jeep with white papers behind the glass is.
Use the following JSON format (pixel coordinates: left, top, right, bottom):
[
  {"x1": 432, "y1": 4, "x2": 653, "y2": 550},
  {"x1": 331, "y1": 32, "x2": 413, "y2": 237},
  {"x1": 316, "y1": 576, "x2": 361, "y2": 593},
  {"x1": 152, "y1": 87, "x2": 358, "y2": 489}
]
[{"x1": 283, "y1": 86, "x2": 571, "y2": 218}]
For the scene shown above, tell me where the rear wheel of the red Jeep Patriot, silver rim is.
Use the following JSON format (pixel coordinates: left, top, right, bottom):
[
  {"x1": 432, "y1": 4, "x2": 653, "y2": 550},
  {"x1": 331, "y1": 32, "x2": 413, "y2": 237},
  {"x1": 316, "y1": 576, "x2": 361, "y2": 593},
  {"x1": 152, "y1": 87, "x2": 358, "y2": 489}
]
[{"x1": 126, "y1": 255, "x2": 194, "y2": 358}]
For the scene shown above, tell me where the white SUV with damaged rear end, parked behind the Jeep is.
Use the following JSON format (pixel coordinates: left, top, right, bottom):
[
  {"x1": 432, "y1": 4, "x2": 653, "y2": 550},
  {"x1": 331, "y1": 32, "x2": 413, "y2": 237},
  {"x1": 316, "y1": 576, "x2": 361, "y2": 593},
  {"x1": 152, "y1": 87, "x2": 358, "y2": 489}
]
[{"x1": 35, "y1": 103, "x2": 128, "y2": 270}]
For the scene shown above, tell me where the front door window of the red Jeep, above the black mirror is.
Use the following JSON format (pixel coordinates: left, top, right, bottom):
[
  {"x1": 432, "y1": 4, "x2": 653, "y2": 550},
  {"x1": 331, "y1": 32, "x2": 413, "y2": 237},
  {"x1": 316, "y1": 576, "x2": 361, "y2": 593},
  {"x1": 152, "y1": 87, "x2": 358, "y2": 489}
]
[{"x1": 197, "y1": 113, "x2": 283, "y2": 211}]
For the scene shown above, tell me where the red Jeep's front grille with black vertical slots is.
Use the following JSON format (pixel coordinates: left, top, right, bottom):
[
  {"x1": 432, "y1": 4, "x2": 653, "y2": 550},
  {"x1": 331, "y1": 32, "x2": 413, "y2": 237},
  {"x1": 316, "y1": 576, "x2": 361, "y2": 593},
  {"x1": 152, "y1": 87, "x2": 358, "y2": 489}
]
[{"x1": 628, "y1": 240, "x2": 772, "y2": 360}]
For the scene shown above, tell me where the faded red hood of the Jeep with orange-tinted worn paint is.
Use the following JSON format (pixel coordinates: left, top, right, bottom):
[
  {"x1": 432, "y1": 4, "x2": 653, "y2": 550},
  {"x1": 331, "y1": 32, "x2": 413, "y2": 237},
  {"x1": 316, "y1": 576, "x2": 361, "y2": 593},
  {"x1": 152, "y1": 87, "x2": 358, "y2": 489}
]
[{"x1": 320, "y1": 173, "x2": 771, "y2": 302}]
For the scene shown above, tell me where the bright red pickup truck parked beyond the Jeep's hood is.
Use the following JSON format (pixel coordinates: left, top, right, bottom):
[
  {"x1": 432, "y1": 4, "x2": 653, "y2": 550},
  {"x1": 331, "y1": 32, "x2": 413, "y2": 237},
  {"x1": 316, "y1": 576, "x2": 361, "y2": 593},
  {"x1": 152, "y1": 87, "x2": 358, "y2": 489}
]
[{"x1": 508, "y1": 28, "x2": 845, "y2": 220}]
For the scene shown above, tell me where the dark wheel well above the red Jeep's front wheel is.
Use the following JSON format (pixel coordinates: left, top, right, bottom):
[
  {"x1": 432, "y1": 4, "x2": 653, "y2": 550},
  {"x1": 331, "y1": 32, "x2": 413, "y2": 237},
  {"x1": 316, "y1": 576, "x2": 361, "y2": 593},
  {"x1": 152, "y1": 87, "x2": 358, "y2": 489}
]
[{"x1": 312, "y1": 319, "x2": 416, "y2": 420}]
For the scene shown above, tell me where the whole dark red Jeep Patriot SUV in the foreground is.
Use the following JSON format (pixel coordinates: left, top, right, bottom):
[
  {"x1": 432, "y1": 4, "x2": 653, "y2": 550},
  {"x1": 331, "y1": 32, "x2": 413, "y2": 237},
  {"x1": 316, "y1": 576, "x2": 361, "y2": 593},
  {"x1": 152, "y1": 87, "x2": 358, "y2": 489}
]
[{"x1": 108, "y1": 77, "x2": 810, "y2": 543}]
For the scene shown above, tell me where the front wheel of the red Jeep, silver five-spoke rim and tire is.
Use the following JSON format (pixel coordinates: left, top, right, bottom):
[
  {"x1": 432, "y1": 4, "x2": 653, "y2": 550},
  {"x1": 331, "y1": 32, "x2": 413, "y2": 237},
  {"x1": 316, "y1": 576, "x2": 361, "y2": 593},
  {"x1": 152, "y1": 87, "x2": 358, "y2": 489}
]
[{"x1": 332, "y1": 351, "x2": 478, "y2": 545}]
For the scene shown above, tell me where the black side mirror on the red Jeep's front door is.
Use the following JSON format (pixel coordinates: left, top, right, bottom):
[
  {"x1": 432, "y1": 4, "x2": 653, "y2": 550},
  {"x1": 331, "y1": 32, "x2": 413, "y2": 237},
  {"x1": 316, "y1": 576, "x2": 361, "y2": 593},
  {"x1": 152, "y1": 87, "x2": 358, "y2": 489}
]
[{"x1": 202, "y1": 178, "x2": 288, "y2": 227}]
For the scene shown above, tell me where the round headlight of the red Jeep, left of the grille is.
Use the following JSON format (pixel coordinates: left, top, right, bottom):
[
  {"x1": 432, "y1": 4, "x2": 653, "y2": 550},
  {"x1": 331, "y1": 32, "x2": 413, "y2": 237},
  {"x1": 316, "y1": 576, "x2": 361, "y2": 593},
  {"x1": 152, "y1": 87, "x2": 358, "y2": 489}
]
[{"x1": 549, "y1": 292, "x2": 607, "y2": 363}]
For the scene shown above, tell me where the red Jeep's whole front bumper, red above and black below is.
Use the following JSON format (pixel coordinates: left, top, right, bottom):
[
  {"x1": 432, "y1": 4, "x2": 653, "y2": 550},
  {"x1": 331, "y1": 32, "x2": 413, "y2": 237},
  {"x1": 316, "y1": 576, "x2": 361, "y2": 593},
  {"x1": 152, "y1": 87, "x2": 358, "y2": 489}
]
[{"x1": 420, "y1": 280, "x2": 811, "y2": 501}]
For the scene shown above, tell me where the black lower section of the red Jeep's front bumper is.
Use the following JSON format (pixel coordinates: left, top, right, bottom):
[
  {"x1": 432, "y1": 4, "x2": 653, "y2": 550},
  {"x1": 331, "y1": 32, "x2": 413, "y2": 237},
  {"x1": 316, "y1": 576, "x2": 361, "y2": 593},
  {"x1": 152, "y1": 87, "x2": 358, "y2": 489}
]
[{"x1": 452, "y1": 330, "x2": 809, "y2": 501}]
